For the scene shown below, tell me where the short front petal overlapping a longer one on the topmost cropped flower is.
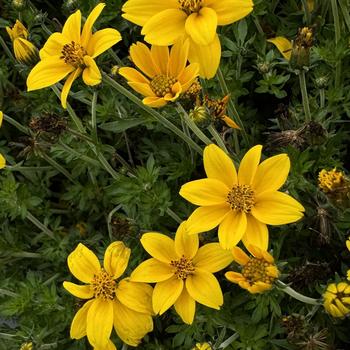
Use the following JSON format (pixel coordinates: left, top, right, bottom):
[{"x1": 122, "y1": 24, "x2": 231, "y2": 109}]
[{"x1": 185, "y1": 7, "x2": 218, "y2": 46}]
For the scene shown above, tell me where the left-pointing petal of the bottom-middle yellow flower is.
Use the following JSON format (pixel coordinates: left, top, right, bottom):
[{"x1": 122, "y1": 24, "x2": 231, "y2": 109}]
[{"x1": 130, "y1": 258, "x2": 174, "y2": 283}]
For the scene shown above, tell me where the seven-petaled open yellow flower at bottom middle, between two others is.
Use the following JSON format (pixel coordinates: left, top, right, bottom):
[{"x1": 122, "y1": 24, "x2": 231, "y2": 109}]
[{"x1": 130, "y1": 222, "x2": 233, "y2": 324}]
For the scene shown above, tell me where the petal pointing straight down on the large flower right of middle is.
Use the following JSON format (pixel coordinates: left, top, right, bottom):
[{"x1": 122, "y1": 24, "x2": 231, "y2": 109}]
[{"x1": 218, "y1": 210, "x2": 247, "y2": 249}]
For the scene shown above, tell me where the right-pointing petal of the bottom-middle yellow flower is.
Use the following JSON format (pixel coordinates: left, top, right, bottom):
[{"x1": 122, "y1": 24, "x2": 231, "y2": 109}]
[{"x1": 193, "y1": 243, "x2": 233, "y2": 273}]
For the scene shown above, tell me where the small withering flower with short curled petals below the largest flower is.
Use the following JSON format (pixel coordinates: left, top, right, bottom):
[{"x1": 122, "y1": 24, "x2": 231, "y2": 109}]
[{"x1": 225, "y1": 245, "x2": 278, "y2": 294}]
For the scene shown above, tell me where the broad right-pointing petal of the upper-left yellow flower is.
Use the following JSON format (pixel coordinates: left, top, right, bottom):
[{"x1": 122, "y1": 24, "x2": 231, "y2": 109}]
[{"x1": 87, "y1": 28, "x2": 122, "y2": 58}]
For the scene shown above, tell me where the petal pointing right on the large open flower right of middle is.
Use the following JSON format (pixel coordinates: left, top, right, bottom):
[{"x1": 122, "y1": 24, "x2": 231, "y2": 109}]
[{"x1": 251, "y1": 191, "x2": 304, "y2": 225}]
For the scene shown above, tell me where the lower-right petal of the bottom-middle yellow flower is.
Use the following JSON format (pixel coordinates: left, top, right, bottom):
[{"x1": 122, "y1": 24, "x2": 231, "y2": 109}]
[{"x1": 186, "y1": 269, "x2": 224, "y2": 309}]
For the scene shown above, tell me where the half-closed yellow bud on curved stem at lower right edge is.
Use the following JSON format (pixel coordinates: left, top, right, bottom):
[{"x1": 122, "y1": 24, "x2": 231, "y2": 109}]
[{"x1": 323, "y1": 282, "x2": 350, "y2": 317}]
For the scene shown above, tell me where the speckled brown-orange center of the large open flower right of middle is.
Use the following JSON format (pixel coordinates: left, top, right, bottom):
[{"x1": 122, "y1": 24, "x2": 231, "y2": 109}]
[{"x1": 227, "y1": 185, "x2": 255, "y2": 213}]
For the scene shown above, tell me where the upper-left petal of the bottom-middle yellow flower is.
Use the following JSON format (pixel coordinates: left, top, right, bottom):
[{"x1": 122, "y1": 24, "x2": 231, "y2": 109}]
[{"x1": 140, "y1": 232, "x2": 178, "y2": 264}]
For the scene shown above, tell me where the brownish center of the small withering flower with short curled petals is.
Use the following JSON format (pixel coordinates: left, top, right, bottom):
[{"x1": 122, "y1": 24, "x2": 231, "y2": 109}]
[{"x1": 242, "y1": 258, "x2": 275, "y2": 284}]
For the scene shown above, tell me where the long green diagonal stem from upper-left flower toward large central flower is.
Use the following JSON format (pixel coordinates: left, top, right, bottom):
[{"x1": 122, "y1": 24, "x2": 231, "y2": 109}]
[{"x1": 103, "y1": 73, "x2": 203, "y2": 154}]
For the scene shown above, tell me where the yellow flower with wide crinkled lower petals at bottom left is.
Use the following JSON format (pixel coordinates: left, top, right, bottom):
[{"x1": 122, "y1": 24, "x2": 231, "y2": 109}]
[{"x1": 63, "y1": 241, "x2": 153, "y2": 350}]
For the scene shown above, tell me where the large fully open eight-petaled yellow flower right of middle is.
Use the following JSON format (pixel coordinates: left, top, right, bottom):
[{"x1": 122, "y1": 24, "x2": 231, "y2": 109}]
[{"x1": 180, "y1": 144, "x2": 304, "y2": 250}]
